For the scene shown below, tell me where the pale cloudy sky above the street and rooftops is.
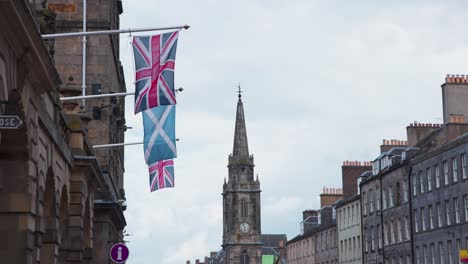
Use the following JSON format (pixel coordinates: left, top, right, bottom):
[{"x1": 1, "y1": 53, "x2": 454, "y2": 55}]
[{"x1": 121, "y1": 0, "x2": 468, "y2": 264}]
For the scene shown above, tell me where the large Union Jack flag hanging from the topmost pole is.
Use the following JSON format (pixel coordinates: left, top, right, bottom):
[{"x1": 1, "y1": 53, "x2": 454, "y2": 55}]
[{"x1": 133, "y1": 31, "x2": 179, "y2": 114}]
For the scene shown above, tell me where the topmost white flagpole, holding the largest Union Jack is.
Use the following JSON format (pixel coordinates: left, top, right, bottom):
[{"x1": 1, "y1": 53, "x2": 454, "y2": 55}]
[{"x1": 42, "y1": 24, "x2": 190, "y2": 39}]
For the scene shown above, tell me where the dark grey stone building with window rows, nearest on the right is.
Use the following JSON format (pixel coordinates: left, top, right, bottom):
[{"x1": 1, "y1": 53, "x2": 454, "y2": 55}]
[{"x1": 411, "y1": 123, "x2": 468, "y2": 263}]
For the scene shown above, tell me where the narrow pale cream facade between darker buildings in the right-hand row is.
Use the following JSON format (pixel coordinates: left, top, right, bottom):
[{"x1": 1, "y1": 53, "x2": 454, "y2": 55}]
[{"x1": 336, "y1": 194, "x2": 362, "y2": 264}]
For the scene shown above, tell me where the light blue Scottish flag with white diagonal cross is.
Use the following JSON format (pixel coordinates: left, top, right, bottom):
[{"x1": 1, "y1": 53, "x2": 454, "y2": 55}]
[{"x1": 143, "y1": 105, "x2": 177, "y2": 164}]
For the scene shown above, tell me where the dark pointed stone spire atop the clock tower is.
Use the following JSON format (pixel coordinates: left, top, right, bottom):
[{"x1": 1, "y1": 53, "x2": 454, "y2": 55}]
[{"x1": 232, "y1": 84, "x2": 249, "y2": 158}]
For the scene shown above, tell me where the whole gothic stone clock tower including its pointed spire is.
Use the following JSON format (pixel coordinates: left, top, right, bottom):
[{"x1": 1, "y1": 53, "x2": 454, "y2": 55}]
[{"x1": 222, "y1": 90, "x2": 262, "y2": 264}]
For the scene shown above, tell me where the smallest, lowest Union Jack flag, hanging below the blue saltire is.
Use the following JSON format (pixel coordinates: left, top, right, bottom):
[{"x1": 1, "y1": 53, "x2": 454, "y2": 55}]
[{"x1": 148, "y1": 160, "x2": 174, "y2": 192}]
